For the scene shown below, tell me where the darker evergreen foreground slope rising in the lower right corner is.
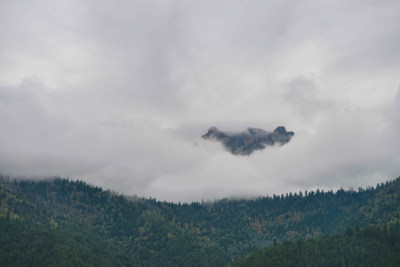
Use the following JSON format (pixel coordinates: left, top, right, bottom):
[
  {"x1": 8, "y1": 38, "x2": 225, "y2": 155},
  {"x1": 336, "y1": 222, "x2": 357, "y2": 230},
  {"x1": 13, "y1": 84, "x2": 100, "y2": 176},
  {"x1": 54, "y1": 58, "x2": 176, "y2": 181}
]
[{"x1": 235, "y1": 224, "x2": 400, "y2": 267}]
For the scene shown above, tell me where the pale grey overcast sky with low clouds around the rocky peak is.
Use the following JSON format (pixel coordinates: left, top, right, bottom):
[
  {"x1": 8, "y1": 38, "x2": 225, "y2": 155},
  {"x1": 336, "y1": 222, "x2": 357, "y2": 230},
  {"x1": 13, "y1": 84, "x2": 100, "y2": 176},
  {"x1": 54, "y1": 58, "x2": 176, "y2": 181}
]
[{"x1": 0, "y1": 0, "x2": 400, "y2": 201}]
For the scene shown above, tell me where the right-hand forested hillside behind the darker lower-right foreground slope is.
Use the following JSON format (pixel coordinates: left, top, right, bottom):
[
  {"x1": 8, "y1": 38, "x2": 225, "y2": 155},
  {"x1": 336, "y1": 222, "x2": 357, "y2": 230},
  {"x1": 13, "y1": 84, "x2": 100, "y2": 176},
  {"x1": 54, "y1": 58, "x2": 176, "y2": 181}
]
[{"x1": 158, "y1": 179, "x2": 400, "y2": 258}]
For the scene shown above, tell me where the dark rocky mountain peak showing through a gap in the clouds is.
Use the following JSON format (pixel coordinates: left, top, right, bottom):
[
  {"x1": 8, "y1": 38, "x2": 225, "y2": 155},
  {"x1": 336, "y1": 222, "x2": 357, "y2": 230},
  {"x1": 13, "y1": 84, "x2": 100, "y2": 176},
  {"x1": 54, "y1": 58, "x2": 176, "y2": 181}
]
[{"x1": 201, "y1": 126, "x2": 294, "y2": 155}]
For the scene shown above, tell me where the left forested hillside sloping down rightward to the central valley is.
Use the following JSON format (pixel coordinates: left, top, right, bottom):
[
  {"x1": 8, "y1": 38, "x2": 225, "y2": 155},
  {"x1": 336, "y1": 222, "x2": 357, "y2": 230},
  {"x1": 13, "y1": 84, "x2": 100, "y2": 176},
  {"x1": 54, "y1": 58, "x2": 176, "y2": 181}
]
[{"x1": 0, "y1": 179, "x2": 228, "y2": 266}]
